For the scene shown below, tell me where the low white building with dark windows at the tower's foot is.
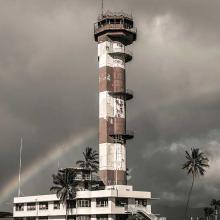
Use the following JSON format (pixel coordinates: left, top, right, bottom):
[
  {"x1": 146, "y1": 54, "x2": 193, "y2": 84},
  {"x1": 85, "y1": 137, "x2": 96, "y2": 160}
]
[{"x1": 13, "y1": 185, "x2": 158, "y2": 220}]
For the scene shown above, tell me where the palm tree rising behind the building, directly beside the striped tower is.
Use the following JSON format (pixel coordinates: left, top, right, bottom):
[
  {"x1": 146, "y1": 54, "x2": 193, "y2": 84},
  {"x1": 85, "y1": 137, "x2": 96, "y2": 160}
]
[{"x1": 76, "y1": 147, "x2": 99, "y2": 180}]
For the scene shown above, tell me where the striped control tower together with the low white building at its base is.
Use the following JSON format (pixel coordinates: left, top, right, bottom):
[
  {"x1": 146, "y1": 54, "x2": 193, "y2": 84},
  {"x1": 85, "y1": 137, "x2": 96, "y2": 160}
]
[{"x1": 13, "y1": 12, "x2": 164, "y2": 220}]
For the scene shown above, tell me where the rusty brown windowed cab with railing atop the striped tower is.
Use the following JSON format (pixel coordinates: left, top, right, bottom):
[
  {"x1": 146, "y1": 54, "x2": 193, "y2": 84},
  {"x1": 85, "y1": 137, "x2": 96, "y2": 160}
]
[{"x1": 94, "y1": 11, "x2": 137, "y2": 45}]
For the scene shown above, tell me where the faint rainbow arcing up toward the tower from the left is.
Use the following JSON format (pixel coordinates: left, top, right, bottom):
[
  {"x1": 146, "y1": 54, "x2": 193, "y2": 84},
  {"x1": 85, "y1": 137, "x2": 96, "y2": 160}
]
[{"x1": 0, "y1": 128, "x2": 96, "y2": 203}]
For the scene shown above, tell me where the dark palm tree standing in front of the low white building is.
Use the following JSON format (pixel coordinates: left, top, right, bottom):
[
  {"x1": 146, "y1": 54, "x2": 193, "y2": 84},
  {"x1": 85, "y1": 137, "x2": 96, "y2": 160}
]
[{"x1": 50, "y1": 168, "x2": 77, "y2": 219}]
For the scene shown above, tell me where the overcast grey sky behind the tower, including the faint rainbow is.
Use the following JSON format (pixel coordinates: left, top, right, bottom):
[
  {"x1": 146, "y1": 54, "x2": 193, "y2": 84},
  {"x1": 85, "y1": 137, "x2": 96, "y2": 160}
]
[{"x1": 0, "y1": 0, "x2": 220, "y2": 217}]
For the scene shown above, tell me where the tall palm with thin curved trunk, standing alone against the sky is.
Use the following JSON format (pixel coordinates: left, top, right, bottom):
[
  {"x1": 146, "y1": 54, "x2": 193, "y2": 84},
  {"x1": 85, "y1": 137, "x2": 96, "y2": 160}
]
[{"x1": 182, "y1": 148, "x2": 209, "y2": 220}]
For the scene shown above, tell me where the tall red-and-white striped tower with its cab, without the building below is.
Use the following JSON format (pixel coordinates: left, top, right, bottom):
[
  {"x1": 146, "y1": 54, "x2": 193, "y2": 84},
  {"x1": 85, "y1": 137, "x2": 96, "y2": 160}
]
[{"x1": 94, "y1": 12, "x2": 136, "y2": 185}]
